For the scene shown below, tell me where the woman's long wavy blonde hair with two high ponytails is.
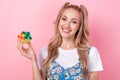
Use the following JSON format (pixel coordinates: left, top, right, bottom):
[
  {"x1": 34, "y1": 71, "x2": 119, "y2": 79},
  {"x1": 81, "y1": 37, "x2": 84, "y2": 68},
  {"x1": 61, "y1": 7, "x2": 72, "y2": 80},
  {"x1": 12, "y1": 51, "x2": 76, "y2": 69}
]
[{"x1": 42, "y1": 2, "x2": 89, "y2": 80}]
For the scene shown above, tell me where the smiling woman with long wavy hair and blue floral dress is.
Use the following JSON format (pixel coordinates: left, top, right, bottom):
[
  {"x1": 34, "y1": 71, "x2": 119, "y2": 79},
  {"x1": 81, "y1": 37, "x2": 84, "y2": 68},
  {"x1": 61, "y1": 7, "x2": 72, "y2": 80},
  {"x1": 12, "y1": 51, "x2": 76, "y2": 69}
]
[{"x1": 17, "y1": 2, "x2": 103, "y2": 80}]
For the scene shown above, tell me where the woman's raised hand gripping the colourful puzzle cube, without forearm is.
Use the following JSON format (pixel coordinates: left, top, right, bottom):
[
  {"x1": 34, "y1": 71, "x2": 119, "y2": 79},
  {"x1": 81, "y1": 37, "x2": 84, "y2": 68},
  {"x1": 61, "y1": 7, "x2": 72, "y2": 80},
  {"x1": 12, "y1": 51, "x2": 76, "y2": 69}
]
[{"x1": 17, "y1": 39, "x2": 36, "y2": 61}]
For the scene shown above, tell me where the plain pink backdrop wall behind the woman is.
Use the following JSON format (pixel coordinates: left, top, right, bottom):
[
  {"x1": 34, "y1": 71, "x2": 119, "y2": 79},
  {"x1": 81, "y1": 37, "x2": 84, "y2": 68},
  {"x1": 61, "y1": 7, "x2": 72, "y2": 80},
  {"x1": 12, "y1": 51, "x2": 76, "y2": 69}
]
[{"x1": 0, "y1": 0, "x2": 120, "y2": 80}]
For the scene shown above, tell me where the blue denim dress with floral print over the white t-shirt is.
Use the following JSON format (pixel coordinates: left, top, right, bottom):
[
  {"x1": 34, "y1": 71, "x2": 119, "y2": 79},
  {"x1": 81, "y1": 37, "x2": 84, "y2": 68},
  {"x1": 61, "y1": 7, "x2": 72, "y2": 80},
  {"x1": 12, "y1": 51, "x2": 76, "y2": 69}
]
[{"x1": 47, "y1": 60, "x2": 85, "y2": 80}]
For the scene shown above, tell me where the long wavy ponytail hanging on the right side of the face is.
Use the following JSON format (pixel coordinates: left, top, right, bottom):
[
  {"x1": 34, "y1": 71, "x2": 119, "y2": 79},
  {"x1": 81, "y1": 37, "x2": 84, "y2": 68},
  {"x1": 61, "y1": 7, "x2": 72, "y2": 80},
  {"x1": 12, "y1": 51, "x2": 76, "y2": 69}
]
[{"x1": 78, "y1": 5, "x2": 89, "y2": 79}]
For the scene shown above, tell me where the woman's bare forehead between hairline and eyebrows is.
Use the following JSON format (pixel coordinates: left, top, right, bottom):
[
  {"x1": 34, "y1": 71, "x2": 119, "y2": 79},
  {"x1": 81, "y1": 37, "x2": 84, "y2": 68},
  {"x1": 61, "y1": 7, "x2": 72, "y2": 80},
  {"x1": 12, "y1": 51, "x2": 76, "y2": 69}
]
[{"x1": 62, "y1": 8, "x2": 80, "y2": 19}]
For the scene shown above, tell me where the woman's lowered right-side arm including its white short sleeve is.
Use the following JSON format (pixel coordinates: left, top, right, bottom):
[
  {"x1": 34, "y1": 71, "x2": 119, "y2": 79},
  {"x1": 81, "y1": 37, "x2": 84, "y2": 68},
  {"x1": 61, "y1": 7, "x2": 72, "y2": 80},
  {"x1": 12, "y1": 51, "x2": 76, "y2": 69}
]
[{"x1": 88, "y1": 47, "x2": 103, "y2": 80}]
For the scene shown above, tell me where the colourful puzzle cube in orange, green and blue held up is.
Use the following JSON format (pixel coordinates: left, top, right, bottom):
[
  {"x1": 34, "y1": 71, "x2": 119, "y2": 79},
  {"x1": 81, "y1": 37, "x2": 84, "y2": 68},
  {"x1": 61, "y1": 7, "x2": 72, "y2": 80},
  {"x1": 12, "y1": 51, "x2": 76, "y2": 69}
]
[{"x1": 18, "y1": 31, "x2": 32, "y2": 43}]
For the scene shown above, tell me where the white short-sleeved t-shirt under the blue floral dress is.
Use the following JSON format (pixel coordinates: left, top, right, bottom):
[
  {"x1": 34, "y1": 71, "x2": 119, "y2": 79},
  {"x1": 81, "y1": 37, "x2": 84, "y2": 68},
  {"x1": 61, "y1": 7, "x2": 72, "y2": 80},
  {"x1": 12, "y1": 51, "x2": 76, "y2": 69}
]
[{"x1": 38, "y1": 46, "x2": 103, "y2": 72}]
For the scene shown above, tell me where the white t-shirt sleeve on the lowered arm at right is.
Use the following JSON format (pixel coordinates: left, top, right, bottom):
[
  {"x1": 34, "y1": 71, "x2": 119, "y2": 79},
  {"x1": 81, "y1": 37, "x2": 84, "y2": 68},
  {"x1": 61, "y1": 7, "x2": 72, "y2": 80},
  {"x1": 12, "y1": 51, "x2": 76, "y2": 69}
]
[{"x1": 88, "y1": 46, "x2": 103, "y2": 72}]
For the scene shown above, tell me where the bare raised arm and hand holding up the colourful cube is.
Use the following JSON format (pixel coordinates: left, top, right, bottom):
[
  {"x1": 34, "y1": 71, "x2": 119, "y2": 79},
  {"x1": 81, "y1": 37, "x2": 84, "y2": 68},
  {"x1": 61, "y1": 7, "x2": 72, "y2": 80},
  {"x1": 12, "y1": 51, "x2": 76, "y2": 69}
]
[{"x1": 17, "y1": 40, "x2": 42, "y2": 80}]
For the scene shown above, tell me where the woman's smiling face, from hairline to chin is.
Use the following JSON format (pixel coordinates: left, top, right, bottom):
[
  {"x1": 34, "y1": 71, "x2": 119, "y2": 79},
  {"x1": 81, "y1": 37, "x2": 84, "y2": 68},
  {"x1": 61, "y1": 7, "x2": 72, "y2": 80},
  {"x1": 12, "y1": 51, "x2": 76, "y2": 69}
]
[{"x1": 58, "y1": 8, "x2": 80, "y2": 39}]
